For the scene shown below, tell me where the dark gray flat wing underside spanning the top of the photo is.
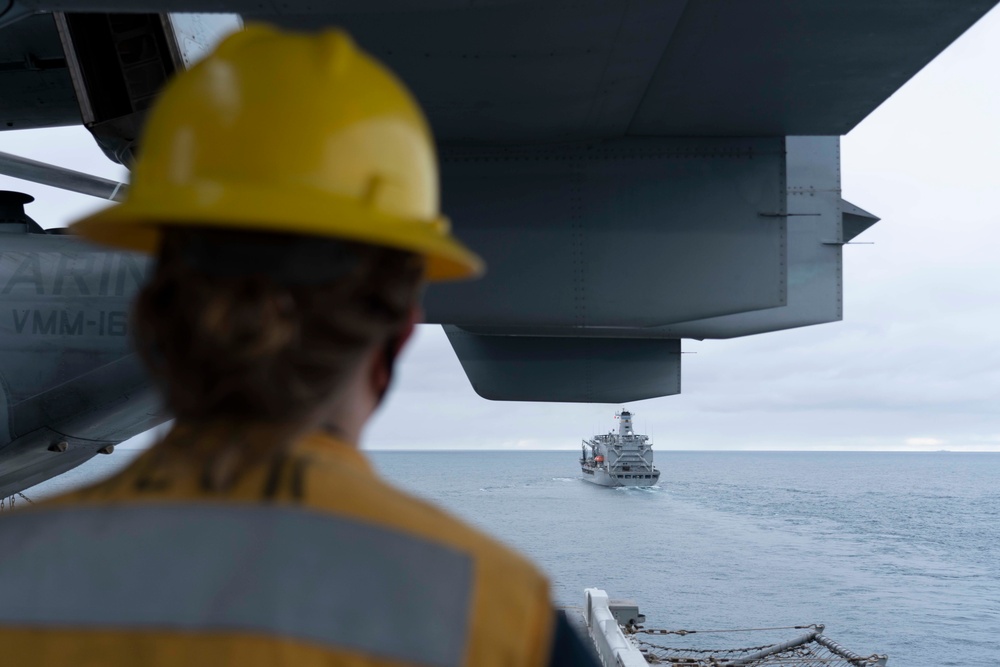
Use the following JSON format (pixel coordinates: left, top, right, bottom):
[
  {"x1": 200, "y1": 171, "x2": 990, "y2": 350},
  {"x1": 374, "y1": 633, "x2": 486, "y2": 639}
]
[{"x1": 0, "y1": 0, "x2": 996, "y2": 138}]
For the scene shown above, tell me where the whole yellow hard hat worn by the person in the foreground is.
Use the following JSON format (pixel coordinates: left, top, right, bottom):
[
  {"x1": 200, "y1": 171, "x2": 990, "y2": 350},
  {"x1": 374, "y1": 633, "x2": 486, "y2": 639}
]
[{"x1": 73, "y1": 25, "x2": 483, "y2": 280}]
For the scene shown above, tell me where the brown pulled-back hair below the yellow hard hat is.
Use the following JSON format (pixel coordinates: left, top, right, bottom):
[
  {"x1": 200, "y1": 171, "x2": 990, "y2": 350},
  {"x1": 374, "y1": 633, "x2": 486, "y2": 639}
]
[{"x1": 133, "y1": 228, "x2": 423, "y2": 425}]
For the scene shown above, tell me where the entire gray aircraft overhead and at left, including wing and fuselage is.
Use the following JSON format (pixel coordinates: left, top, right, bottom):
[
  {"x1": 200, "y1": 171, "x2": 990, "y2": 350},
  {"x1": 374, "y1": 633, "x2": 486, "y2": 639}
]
[{"x1": 0, "y1": 0, "x2": 997, "y2": 495}]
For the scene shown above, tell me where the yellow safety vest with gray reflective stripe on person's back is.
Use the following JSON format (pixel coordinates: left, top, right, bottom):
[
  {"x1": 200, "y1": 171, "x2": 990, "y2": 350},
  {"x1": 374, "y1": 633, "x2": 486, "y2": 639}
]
[{"x1": 0, "y1": 435, "x2": 554, "y2": 667}]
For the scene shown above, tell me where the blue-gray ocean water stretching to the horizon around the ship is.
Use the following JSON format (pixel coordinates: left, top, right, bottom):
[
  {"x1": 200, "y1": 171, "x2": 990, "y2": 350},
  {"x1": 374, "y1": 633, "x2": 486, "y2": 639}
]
[{"x1": 21, "y1": 451, "x2": 1000, "y2": 666}]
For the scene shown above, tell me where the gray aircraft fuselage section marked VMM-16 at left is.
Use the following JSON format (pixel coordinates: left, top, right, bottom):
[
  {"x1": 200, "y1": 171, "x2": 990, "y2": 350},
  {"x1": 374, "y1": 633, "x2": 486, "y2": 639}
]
[{"x1": 0, "y1": 195, "x2": 159, "y2": 497}]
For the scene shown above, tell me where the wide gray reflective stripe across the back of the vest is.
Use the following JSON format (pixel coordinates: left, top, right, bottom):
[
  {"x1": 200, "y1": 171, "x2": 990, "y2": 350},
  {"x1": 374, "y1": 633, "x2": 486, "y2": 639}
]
[{"x1": 0, "y1": 504, "x2": 473, "y2": 667}]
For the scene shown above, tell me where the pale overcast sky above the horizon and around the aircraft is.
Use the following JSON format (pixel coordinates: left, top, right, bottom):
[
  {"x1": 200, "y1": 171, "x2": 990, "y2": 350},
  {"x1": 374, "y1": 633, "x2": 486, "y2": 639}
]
[{"x1": 0, "y1": 10, "x2": 1000, "y2": 451}]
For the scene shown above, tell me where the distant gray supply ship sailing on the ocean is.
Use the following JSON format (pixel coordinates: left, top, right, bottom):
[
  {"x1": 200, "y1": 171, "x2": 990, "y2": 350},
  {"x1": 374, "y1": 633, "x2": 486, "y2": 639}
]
[{"x1": 580, "y1": 410, "x2": 660, "y2": 486}]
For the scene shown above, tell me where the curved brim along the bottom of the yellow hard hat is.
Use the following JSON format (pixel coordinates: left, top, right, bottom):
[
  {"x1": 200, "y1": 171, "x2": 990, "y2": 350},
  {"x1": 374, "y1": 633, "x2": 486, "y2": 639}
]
[{"x1": 72, "y1": 183, "x2": 485, "y2": 282}]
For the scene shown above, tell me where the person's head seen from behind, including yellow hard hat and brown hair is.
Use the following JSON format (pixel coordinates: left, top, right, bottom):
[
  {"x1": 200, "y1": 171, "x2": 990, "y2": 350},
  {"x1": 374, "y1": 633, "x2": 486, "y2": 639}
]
[{"x1": 68, "y1": 26, "x2": 482, "y2": 460}]
